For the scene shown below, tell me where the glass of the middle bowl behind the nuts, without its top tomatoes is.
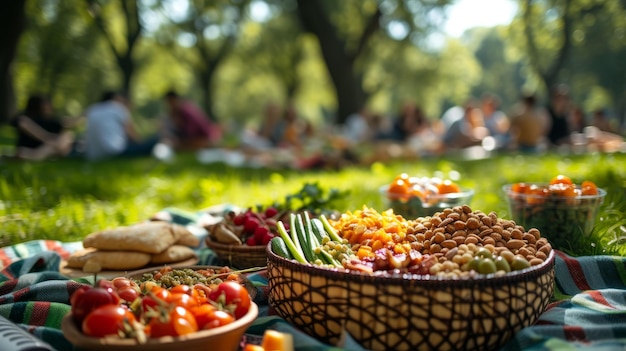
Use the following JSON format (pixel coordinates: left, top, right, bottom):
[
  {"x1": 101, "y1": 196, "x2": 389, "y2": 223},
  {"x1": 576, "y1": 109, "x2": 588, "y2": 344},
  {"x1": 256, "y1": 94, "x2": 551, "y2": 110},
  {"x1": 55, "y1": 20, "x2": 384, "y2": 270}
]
[{"x1": 379, "y1": 185, "x2": 474, "y2": 219}]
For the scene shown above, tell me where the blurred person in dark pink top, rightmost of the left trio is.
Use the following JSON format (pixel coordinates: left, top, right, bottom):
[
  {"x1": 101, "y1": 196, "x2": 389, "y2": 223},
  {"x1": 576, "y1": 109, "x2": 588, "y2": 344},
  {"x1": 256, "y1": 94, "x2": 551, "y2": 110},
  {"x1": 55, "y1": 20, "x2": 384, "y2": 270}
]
[{"x1": 164, "y1": 90, "x2": 222, "y2": 151}]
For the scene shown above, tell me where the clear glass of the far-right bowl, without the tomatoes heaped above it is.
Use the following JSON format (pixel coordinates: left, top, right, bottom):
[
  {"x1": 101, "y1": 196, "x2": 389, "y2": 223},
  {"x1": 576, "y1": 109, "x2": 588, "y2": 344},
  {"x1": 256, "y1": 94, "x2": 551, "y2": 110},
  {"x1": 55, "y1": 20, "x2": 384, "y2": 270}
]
[{"x1": 502, "y1": 183, "x2": 606, "y2": 249}]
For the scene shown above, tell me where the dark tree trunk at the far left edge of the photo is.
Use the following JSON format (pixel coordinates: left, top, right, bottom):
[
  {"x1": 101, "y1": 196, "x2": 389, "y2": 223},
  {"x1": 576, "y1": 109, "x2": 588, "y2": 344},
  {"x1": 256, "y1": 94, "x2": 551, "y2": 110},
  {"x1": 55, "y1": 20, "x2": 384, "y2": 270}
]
[{"x1": 0, "y1": 0, "x2": 26, "y2": 124}]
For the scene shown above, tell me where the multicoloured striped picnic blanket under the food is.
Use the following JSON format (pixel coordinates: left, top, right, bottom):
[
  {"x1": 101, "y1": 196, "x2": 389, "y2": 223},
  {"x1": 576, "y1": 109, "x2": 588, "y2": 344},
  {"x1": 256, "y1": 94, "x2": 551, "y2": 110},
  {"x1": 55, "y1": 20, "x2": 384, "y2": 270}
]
[{"x1": 0, "y1": 241, "x2": 626, "y2": 351}]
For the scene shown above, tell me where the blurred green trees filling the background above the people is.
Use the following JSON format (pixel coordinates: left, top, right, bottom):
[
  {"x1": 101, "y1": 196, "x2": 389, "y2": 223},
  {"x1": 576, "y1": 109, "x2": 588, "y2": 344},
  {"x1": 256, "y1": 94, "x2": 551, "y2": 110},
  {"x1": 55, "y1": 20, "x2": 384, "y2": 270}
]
[{"x1": 0, "y1": 0, "x2": 626, "y2": 132}]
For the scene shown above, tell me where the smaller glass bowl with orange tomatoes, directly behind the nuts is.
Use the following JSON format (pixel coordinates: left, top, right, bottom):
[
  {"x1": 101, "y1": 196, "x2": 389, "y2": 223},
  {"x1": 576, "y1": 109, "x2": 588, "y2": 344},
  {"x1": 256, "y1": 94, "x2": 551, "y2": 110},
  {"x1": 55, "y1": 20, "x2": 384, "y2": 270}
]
[{"x1": 380, "y1": 173, "x2": 474, "y2": 218}]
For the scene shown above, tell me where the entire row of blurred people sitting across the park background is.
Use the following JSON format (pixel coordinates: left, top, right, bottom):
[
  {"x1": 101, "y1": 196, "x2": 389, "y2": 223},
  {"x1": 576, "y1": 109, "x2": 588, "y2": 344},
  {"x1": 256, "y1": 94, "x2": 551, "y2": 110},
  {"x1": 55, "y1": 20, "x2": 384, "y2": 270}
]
[{"x1": 7, "y1": 85, "x2": 623, "y2": 164}]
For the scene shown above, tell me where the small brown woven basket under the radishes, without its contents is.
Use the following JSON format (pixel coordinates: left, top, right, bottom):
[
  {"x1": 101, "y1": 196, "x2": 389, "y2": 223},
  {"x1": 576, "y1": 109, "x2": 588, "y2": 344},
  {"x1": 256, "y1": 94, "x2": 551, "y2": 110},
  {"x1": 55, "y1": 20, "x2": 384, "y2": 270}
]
[{"x1": 206, "y1": 237, "x2": 267, "y2": 269}]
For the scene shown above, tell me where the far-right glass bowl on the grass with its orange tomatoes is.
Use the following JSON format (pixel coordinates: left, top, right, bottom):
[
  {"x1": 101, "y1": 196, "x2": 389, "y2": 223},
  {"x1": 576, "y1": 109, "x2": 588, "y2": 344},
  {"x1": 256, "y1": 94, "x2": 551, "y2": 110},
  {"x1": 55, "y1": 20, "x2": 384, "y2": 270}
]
[{"x1": 502, "y1": 175, "x2": 606, "y2": 249}]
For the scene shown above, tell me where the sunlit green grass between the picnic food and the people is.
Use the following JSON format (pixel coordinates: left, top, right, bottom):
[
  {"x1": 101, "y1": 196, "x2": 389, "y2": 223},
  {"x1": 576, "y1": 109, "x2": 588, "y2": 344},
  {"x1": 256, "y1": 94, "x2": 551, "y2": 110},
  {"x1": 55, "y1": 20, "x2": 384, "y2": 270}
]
[{"x1": 0, "y1": 154, "x2": 626, "y2": 256}]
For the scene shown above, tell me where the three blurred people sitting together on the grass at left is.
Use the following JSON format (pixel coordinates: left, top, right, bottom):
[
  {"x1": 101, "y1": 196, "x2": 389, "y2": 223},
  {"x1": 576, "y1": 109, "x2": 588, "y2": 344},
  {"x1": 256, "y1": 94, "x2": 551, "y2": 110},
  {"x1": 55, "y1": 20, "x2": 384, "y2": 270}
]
[{"x1": 12, "y1": 91, "x2": 222, "y2": 160}]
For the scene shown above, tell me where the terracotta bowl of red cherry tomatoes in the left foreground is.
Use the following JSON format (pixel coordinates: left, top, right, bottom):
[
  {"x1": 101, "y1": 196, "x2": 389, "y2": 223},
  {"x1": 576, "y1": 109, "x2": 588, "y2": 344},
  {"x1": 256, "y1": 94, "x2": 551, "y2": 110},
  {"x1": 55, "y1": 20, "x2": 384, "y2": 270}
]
[{"x1": 61, "y1": 266, "x2": 258, "y2": 351}]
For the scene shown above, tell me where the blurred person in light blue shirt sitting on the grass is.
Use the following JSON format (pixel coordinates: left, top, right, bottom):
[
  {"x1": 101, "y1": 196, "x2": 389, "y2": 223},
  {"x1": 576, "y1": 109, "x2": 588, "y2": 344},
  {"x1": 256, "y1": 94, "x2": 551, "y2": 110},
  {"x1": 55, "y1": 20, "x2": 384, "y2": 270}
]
[{"x1": 84, "y1": 91, "x2": 158, "y2": 161}]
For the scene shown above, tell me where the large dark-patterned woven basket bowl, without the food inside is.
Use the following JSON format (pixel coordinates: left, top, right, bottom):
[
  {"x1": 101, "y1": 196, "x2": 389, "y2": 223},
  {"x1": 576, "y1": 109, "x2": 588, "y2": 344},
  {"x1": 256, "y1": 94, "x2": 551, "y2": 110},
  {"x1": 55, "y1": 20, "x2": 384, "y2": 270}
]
[{"x1": 267, "y1": 247, "x2": 554, "y2": 350}]
